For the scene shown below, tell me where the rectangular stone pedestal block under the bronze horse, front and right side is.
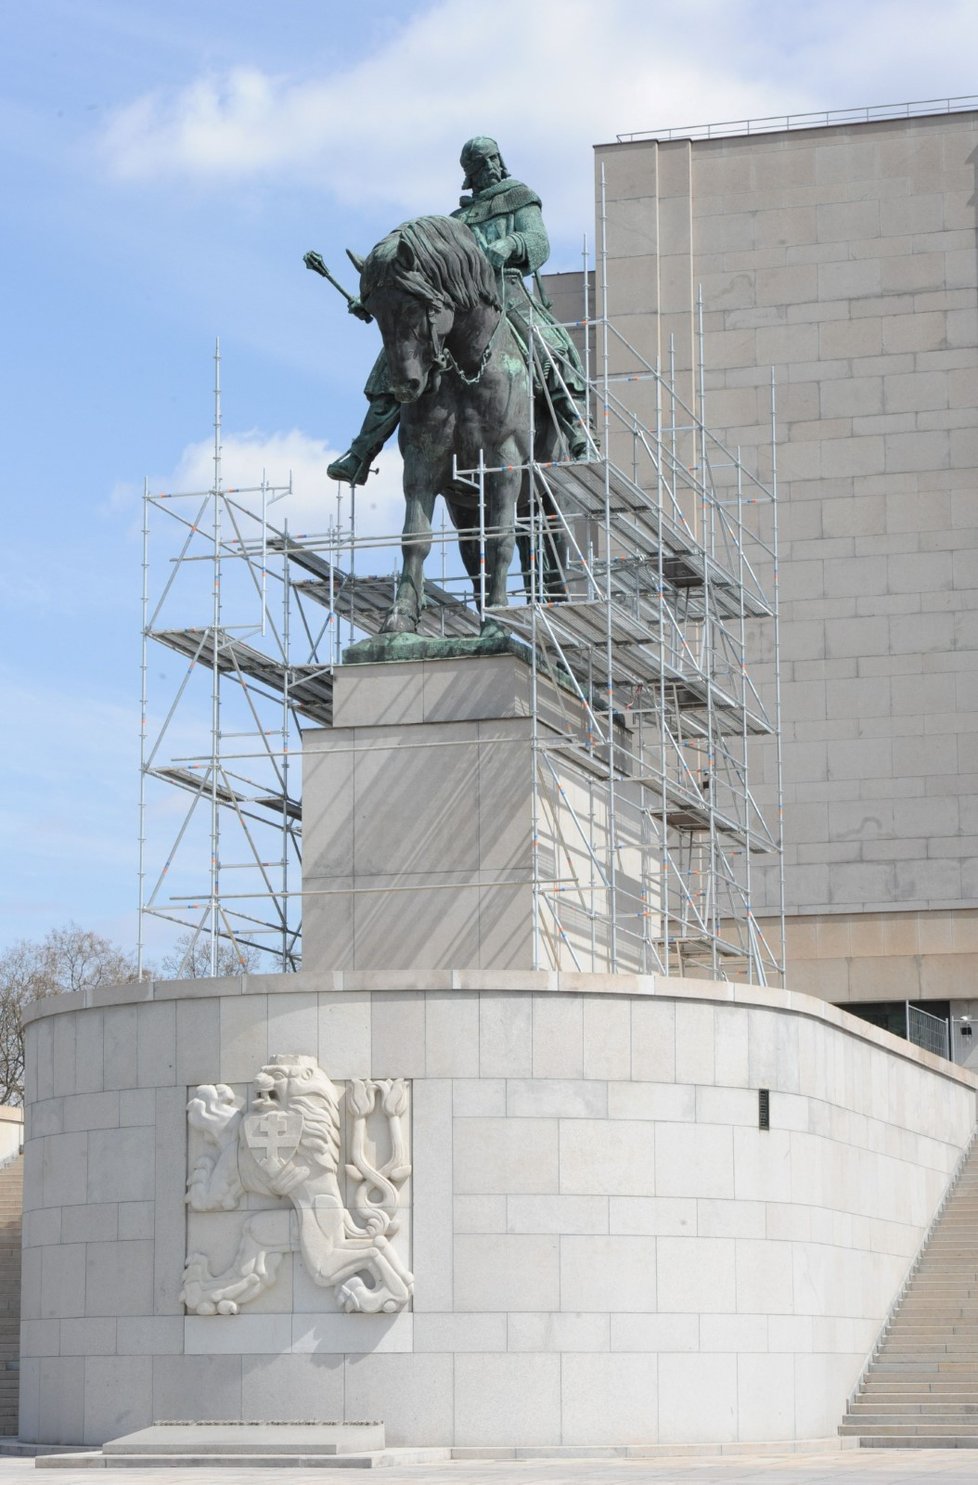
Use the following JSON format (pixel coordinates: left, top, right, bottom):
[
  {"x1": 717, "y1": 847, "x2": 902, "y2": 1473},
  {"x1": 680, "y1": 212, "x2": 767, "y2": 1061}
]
[{"x1": 303, "y1": 655, "x2": 654, "y2": 971}]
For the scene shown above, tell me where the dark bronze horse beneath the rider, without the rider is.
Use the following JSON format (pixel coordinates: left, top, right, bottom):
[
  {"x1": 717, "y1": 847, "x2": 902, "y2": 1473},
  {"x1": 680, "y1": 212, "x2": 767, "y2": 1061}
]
[{"x1": 361, "y1": 217, "x2": 565, "y2": 634}]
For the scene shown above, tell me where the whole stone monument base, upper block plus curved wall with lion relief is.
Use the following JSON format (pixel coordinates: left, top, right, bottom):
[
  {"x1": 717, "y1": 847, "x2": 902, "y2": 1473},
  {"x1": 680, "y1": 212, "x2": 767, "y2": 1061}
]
[{"x1": 21, "y1": 656, "x2": 975, "y2": 1451}]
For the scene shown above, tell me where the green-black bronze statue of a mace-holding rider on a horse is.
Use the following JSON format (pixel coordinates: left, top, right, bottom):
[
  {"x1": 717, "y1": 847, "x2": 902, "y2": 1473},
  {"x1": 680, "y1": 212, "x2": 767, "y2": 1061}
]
[{"x1": 306, "y1": 137, "x2": 589, "y2": 633}]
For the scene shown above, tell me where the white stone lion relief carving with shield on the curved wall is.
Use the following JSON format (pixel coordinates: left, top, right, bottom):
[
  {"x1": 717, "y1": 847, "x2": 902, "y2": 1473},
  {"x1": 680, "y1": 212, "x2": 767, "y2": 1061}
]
[{"x1": 181, "y1": 1053, "x2": 414, "y2": 1314}]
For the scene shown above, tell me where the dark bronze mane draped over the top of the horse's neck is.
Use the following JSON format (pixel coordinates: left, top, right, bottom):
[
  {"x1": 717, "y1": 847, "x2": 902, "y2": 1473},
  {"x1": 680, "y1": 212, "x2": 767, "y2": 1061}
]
[{"x1": 361, "y1": 217, "x2": 502, "y2": 310}]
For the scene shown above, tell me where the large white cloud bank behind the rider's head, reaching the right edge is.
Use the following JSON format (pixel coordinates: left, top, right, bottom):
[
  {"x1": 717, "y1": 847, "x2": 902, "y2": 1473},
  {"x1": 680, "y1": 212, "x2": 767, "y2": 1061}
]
[{"x1": 102, "y1": 0, "x2": 978, "y2": 245}]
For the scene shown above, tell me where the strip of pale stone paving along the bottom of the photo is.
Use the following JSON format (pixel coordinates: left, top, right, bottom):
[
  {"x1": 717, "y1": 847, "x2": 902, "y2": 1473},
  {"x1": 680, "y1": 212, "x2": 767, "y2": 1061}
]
[{"x1": 0, "y1": 1449, "x2": 978, "y2": 1485}]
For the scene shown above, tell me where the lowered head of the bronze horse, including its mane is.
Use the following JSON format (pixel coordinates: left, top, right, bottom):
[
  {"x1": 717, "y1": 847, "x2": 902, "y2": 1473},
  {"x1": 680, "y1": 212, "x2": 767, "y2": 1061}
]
[{"x1": 361, "y1": 217, "x2": 502, "y2": 402}]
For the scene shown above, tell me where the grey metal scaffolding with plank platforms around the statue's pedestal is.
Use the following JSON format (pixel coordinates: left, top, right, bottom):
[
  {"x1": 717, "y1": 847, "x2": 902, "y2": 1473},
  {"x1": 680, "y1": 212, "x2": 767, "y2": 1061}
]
[{"x1": 140, "y1": 225, "x2": 785, "y2": 985}]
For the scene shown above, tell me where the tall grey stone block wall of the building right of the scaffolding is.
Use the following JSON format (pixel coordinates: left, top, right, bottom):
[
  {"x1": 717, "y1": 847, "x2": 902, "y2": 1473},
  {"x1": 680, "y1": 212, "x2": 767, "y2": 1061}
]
[{"x1": 598, "y1": 113, "x2": 978, "y2": 996}]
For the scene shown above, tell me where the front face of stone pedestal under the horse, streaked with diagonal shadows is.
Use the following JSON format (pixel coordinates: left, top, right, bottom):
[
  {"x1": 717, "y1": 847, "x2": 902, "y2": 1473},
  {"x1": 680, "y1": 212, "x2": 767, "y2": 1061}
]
[{"x1": 303, "y1": 655, "x2": 533, "y2": 970}]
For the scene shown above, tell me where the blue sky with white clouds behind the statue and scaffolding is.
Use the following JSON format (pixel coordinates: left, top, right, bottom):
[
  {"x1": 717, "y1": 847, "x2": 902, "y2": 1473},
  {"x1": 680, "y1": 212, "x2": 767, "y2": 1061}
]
[{"x1": 0, "y1": 0, "x2": 978, "y2": 952}]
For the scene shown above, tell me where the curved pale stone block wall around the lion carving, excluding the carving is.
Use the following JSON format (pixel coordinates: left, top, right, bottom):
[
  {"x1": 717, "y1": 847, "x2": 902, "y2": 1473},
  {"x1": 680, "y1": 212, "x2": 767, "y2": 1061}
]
[{"x1": 21, "y1": 973, "x2": 975, "y2": 1445}]
